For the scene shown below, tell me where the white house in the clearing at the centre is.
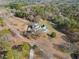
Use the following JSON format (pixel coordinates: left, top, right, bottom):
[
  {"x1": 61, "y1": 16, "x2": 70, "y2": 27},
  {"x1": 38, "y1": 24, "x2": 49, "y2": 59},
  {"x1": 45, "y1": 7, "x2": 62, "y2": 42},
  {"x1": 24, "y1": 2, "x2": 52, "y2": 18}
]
[{"x1": 28, "y1": 23, "x2": 48, "y2": 33}]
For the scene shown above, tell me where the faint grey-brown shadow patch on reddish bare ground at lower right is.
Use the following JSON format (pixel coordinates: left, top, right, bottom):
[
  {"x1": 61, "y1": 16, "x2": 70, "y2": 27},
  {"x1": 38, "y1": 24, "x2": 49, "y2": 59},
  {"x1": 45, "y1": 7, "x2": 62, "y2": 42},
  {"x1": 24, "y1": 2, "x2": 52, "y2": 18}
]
[{"x1": 53, "y1": 42, "x2": 75, "y2": 53}]
